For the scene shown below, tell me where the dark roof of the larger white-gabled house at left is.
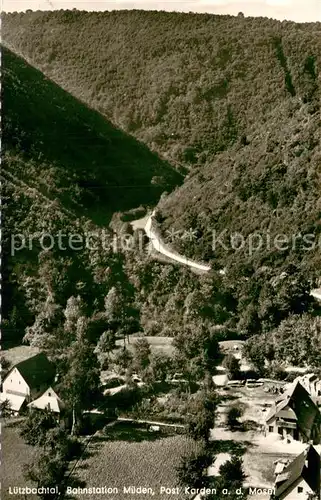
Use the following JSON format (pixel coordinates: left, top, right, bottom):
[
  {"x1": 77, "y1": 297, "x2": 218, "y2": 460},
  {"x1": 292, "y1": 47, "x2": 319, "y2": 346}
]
[{"x1": 14, "y1": 352, "x2": 55, "y2": 389}]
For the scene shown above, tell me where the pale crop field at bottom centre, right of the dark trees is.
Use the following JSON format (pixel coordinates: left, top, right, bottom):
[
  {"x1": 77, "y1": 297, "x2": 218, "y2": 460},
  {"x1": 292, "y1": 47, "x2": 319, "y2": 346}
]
[{"x1": 76, "y1": 424, "x2": 197, "y2": 500}]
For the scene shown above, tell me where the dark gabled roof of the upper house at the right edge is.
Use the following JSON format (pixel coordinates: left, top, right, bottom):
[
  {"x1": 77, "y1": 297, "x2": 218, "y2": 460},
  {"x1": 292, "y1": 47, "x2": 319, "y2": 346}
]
[{"x1": 266, "y1": 382, "x2": 320, "y2": 439}]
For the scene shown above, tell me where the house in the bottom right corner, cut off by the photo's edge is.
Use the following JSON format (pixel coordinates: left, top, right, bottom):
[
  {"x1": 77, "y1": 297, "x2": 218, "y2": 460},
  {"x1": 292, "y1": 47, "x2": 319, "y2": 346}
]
[{"x1": 271, "y1": 445, "x2": 321, "y2": 500}]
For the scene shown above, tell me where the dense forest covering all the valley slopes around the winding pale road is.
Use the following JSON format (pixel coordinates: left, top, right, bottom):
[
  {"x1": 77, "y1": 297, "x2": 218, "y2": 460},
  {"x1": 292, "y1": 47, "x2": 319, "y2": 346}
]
[{"x1": 3, "y1": 10, "x2": 321, "y2": 362}]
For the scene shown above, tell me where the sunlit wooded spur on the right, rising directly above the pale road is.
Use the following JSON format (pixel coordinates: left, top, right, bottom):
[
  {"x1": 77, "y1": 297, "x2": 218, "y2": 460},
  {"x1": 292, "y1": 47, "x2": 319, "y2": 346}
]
[{"x1": 158, "y1": 98, "x2": 321, "y2": 274}]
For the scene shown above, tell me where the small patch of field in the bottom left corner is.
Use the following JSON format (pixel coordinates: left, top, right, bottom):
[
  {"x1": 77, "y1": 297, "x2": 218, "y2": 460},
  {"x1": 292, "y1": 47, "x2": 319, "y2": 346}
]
[{"x1": 1, "y1": 423, "x2": 38, "y2": 500}]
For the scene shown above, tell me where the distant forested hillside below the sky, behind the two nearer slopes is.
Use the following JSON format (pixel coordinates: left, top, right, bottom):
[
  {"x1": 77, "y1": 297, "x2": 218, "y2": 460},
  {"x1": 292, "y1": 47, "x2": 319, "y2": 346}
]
[{"x1": 3, "y1": 11, "x2": 321, "y2": 168}]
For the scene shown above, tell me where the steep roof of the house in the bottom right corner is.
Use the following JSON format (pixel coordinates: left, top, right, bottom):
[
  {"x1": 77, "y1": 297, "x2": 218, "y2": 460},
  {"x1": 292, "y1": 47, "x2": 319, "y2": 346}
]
[{"x1": 275, "y1": 445, "x2": 320, "y2": 498}]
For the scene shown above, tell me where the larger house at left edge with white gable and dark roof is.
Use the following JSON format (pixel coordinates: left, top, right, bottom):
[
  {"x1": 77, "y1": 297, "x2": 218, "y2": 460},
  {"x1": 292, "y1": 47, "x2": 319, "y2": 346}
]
[{"x1": 0, "y1": 353, "x2": 55, "y2": 413}]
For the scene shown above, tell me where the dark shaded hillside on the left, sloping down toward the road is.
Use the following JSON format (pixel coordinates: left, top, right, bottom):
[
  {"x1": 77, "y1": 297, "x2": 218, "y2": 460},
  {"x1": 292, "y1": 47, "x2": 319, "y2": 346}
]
[{"x1": 2, "y1": 49, "x2": 180, "y2": 224}]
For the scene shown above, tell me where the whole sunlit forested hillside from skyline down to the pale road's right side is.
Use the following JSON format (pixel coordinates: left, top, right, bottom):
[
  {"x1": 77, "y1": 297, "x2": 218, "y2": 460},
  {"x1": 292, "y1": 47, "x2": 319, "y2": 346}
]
[{"x1": 3, "y1": 11, "x2": 321, "y2": 269}]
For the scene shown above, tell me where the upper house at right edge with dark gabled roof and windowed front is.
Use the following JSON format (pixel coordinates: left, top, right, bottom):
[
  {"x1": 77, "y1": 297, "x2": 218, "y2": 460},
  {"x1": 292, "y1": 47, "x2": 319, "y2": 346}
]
[{"x1": 266, "y1": 381, "x2": 321, "y2": 444}]
